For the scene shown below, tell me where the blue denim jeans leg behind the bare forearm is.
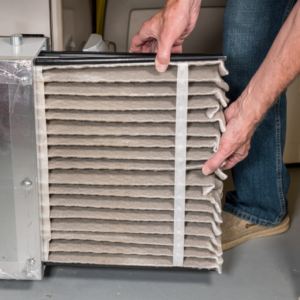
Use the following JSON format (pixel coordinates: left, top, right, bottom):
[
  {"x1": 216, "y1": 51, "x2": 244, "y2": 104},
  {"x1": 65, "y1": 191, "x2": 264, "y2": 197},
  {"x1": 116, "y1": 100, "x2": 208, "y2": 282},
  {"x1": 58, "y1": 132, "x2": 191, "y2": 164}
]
[{"x1": 223, "y1": 0, "x2": 295, "y2": 226}]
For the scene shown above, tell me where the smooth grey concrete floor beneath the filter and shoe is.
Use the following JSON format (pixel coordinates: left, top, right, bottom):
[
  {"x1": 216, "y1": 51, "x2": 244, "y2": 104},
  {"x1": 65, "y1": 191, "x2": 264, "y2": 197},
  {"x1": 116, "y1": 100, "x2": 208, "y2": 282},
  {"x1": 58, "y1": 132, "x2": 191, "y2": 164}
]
[{"x1": 0, "y1": 168, "x2": 300, "y2": 300}]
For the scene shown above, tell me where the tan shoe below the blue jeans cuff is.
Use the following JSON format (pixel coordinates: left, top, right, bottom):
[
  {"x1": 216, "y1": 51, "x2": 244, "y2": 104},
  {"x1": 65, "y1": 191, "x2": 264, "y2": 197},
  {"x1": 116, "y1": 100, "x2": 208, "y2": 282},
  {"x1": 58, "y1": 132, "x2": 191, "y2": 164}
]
[{"x1": 221, "y1": 211, "x2": 290, "y2": 251}]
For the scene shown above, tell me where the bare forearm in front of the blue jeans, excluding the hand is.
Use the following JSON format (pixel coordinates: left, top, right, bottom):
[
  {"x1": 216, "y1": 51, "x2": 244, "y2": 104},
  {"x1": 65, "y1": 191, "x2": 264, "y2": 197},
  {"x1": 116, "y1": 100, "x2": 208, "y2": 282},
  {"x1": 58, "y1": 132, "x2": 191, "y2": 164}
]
[{"x1": 238, "y1": 1, "x2": 300, "y2": 123}]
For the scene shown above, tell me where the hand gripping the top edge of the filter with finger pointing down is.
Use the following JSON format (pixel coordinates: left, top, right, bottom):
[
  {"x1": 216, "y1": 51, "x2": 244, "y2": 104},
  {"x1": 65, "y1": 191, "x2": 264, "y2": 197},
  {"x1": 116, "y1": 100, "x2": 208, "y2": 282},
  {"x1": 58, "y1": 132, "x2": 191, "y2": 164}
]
[{"x1": 129, "y1": 0, "x2": 201, "y2": 72}]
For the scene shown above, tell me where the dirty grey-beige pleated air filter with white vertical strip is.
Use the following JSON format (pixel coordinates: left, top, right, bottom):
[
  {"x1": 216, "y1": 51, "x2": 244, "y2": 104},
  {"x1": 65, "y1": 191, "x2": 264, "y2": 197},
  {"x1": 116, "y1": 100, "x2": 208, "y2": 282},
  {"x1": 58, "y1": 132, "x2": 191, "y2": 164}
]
[{"x1": 35, "y1": 60, "x2": 228, "y2": 272}]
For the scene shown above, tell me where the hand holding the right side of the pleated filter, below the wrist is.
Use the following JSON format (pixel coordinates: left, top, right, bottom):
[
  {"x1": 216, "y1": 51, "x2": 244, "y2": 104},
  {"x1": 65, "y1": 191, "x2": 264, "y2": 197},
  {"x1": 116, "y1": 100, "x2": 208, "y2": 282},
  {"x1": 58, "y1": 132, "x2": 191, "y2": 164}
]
[{"x1": 202, "y1": 95, "x2": 262, "y2": 175}]
